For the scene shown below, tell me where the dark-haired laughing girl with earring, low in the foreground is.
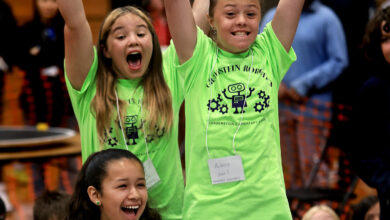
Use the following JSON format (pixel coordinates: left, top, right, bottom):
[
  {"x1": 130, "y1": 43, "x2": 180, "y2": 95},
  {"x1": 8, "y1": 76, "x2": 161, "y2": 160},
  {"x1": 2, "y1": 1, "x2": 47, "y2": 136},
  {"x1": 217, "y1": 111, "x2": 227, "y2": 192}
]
[{"x1": 68, "y1": 149, "x2": 161, "y2": 220}]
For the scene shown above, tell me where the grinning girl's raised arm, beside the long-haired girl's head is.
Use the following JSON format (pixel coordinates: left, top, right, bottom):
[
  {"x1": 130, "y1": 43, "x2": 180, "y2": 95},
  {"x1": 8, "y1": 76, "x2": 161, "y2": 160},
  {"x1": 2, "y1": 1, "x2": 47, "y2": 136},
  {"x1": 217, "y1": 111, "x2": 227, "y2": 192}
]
[{"x1": 164, "y1": 0, "x2": 197, "y2": 63}]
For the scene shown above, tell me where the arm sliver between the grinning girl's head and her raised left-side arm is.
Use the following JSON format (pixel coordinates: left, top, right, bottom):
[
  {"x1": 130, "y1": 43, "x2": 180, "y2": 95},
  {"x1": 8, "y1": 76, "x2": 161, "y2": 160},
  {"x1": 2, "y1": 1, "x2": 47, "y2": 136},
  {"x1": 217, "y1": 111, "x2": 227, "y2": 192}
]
[{"x1": 192, "y1": 0, "x2": 210, "y2": 35}]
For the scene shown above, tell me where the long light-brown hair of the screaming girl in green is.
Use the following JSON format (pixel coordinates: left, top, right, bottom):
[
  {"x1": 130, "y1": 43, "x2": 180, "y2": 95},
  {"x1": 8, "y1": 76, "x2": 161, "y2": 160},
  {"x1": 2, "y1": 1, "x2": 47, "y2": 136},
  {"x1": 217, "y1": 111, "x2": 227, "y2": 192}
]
[{"x1": 91, "y1": 6, "x2": 173, "y2": 143}]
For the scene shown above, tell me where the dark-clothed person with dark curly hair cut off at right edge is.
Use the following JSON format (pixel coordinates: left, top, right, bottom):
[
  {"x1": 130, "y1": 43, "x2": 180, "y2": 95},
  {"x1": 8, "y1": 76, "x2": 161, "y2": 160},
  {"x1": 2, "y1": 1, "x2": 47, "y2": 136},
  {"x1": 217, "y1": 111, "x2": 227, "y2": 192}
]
[{"x1": 346, "y1": 1, "x2": 390, "y2": 220}]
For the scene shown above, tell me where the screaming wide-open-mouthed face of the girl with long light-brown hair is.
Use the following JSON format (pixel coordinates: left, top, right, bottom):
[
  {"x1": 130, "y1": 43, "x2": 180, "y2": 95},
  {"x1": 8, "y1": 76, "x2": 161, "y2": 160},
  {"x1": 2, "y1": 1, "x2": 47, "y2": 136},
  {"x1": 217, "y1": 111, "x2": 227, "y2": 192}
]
[{"x1": 104, "y1": 13, "x2": 153, "y2": 79}]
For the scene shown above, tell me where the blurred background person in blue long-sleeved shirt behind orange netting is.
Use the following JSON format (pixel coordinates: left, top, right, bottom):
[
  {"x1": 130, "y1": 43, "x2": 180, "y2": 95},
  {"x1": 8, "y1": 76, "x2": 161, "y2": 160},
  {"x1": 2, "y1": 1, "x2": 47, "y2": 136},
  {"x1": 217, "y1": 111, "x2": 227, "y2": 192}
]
[{"x1": 260, "y1": 0, "x2": 348, "y2": 188}]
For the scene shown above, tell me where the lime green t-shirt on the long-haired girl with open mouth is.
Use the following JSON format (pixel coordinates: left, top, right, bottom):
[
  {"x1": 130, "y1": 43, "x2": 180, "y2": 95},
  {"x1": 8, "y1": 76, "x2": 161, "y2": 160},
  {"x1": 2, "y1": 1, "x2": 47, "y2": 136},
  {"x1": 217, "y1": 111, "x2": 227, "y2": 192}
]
[{"x1": 66, "y1": 49, "x2": 184, "y2": 219}]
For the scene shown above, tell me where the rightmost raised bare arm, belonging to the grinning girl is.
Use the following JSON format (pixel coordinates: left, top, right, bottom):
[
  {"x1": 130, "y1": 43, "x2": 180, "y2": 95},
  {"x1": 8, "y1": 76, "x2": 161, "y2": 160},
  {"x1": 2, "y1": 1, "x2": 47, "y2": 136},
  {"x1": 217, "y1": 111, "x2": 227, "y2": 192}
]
[{"x1": 272, "y1": 0, "x2": 305, "y2": 51}]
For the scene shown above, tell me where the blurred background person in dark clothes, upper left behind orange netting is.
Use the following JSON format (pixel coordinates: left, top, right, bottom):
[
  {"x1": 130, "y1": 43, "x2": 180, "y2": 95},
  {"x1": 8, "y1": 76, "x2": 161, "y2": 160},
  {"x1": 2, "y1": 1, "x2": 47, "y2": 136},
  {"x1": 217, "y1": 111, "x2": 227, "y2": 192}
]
[{"x1": 18, "y1": 0, "x2": 73, "y2": 127}]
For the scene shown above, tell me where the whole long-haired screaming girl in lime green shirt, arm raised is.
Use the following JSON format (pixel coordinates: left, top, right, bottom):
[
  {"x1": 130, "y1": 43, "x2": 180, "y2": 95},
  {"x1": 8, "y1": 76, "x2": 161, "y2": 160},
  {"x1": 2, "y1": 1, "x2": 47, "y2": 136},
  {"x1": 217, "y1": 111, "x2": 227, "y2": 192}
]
[{"x1": 57, "y1": 0, "x2": 193, "y2": 219}]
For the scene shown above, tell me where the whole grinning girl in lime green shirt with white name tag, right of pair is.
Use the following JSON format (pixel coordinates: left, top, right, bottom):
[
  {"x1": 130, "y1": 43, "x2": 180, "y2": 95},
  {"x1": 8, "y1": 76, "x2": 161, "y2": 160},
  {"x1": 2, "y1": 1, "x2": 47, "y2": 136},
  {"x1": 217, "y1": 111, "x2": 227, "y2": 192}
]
[{"x1": 165, "y1": 0, "x2": 304, "y2": 220}]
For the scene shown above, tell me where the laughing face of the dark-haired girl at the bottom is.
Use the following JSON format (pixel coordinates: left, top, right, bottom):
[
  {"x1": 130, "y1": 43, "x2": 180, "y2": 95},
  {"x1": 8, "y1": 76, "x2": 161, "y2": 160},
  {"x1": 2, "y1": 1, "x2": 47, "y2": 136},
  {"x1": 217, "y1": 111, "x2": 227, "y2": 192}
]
[{"x1": 96, "y1": 158, "x2": 148, "y2": 220}]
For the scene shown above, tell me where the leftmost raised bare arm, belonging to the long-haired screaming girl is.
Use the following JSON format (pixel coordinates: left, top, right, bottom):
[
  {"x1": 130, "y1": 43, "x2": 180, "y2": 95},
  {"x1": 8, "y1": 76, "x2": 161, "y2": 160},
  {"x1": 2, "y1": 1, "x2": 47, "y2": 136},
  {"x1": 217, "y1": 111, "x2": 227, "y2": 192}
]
[{"x1": 57, "y1": 0, "x2": 94, "y2": 90}]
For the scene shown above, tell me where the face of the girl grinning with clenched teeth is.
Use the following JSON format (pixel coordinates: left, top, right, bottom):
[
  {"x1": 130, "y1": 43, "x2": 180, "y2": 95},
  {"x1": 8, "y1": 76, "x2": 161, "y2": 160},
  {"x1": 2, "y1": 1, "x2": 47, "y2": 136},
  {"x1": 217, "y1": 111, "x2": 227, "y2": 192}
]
[{"x1": 209, "y1": 0, "x2": 261, "y2": 53}]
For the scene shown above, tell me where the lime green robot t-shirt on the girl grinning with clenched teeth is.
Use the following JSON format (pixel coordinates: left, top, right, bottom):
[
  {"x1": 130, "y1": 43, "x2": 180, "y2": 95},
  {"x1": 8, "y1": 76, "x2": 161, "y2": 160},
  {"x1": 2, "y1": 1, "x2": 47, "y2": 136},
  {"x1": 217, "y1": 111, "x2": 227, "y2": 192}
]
[{"x1": 171, "y1": 24, "x2": 296, "y2": 220}]
